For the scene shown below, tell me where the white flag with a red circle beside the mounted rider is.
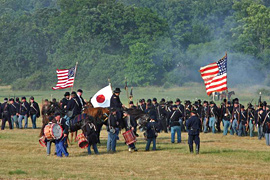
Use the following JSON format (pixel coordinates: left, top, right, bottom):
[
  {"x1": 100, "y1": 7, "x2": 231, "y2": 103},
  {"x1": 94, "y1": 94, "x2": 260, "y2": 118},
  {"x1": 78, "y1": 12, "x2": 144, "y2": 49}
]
[{"x1": 91, "y1": 84, "x2": 113, "y2": 108}]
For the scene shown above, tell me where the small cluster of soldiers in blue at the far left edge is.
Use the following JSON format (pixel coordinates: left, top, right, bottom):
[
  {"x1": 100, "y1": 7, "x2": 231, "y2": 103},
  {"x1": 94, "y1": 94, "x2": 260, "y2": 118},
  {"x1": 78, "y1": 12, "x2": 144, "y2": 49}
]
[{"x1": 0, "y1": 96, "x2": 40, "y2": 130}]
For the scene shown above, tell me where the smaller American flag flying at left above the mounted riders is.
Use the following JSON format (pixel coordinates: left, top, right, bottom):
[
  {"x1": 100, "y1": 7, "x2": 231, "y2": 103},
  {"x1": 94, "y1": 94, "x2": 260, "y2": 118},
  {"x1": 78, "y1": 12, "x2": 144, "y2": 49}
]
[{"x1": 52, "y1": 66, "x2": 76, "y2": 90}]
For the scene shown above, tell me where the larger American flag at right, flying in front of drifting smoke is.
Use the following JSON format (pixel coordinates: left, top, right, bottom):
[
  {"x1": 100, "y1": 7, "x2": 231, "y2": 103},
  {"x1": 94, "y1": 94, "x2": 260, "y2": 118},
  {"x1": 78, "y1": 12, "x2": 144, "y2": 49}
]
[{"x1": 200, "y1": 53, "x2": 227, "y2": 95}]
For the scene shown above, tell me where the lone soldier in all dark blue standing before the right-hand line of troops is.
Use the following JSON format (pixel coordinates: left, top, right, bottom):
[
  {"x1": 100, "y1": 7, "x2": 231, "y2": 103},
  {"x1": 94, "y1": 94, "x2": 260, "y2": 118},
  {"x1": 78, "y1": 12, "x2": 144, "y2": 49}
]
[{"x1": 186, "y1": 111, "x2": 201, "y2": 154}]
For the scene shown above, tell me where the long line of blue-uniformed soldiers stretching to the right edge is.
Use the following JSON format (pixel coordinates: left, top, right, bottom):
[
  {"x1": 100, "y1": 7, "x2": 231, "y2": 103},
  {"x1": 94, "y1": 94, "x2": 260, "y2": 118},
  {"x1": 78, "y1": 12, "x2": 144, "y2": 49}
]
[{"x1": 130, "y1": 98, "x2": 270, "y2": 145}]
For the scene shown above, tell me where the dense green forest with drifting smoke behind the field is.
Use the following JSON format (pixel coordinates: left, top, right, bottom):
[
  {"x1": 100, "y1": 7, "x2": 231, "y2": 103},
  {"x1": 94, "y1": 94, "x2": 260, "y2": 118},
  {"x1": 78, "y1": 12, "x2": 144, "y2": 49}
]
[{"x1": 0, "y1": 0, "x2": 270, "y2": 89}]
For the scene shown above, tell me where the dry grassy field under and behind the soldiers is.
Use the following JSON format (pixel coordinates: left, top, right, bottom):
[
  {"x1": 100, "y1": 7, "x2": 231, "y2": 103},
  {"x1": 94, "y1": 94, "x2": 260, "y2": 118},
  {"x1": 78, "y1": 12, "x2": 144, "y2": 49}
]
[{"x1": 0, "y1": 83, "x2": 270, "y2": 179}]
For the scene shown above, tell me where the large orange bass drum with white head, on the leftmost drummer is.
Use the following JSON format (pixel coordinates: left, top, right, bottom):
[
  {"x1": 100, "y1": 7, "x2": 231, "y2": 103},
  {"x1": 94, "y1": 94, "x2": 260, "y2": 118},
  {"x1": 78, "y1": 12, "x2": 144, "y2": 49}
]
[{"x1": 44, "y1": 123, "x2": 63, "y2": 140}]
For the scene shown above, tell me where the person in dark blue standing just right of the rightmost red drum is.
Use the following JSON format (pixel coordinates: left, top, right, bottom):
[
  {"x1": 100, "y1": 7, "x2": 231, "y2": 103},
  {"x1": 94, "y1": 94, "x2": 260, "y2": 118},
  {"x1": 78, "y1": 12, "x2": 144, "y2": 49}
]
[{"x1": 145, "y1": 116, "x2": 158, "y2": 151}]
